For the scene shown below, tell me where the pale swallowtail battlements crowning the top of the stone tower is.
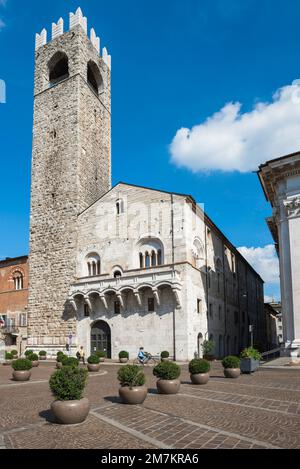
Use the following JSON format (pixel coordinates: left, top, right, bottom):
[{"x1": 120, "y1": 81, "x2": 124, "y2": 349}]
[{"x1": 35, "y1": 8, "x2": 111, "y2": 68}]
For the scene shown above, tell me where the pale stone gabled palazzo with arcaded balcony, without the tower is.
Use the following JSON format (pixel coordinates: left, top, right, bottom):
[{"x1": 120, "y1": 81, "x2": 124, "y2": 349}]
[{"x1": 69, "y1": 183, "x2": 265, "y2": 360}]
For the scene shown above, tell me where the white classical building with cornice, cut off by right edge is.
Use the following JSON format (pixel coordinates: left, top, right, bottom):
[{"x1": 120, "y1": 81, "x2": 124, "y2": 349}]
[{"x1": 258, "y1": 152, "x2": 300, "y2": 359}]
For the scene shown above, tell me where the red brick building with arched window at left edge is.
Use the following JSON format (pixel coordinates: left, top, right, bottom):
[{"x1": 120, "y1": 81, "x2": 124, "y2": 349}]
[{"x1": 0, "y1": 256, "x2": 28, "y2": 354}]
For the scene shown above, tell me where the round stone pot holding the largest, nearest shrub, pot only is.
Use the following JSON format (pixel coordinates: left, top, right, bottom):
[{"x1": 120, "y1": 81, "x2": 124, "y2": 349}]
[{"x1": 51, "y1": 397, "x2": 90, "y2": 425}]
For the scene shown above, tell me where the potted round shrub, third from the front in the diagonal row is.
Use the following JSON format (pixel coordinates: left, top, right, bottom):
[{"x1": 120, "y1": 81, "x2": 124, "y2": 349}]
[{"x1": 153, "y1": 361, "x2": 181, "y2": 394}]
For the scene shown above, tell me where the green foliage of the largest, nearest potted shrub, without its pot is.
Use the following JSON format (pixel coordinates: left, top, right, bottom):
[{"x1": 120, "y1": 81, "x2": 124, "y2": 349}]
[{"x1": 49, "y1": 366, "x2": 88, "y2": 401}]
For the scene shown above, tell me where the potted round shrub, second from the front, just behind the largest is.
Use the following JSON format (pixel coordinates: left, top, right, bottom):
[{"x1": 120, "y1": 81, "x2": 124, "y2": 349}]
[{"x1": 118, "y1": 365, "x2": 147, "y2": 404}]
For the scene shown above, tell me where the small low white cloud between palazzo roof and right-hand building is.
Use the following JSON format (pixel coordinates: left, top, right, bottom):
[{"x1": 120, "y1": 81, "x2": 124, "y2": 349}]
[{"x1": 238, "y1": 244, "x2": 279, "y2": 285}]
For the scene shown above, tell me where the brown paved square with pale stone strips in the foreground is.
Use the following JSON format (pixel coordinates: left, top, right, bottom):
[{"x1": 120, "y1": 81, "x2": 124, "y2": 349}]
[{"x1": 0, "y1": 363, "x2": 300, "y2": 449}]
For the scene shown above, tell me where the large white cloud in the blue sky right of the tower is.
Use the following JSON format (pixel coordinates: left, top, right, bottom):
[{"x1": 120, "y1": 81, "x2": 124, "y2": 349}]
[{"x1": 170, "y1": 80, "x2": 300, "y2": 172}]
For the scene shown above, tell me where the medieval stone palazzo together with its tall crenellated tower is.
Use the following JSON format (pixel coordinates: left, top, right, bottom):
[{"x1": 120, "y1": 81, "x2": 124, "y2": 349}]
[{"x1": 27, "y1": 9, "x2": 265, "y2": 360}]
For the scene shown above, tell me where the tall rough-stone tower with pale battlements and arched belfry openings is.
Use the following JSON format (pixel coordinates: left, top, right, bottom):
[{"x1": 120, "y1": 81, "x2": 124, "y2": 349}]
[{"x1": 28, "y1": 8, "x2": 111, "y2": 353}]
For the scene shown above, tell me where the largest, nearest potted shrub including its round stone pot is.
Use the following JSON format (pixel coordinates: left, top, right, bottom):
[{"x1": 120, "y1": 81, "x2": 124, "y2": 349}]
[{"x1": 49, "y1": 366, "x2": 90, "y2": 425}]
